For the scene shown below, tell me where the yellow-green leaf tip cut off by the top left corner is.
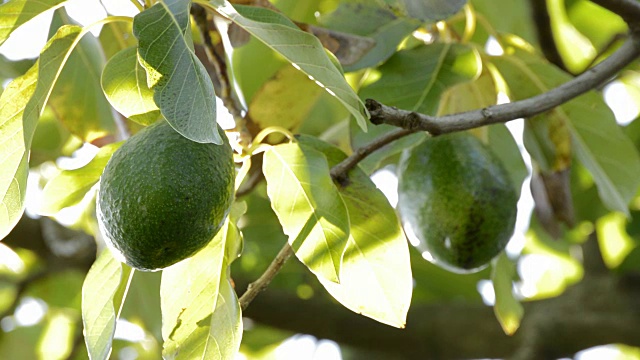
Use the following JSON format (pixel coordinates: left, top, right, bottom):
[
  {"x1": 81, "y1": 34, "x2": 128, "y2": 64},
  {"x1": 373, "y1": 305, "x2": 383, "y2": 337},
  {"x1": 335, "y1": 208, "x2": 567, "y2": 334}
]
[{"x1": 0, "y1": 0, "x2": 66, "y2": 45}]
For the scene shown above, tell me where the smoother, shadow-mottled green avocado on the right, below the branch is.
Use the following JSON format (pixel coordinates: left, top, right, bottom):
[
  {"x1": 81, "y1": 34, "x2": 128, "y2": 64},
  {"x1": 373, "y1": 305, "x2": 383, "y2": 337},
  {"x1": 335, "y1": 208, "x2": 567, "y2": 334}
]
[{"x1": 398, "y1": 132, "x2": 518, "y2": 273}]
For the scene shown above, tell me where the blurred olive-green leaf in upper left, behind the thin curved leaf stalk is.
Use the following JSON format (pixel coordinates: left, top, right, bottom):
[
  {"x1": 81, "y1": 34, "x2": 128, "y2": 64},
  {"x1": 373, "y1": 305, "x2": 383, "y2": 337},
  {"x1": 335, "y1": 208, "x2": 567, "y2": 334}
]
[{"x1": 49, "y1": 9, "x2": 116, "y2": 142}]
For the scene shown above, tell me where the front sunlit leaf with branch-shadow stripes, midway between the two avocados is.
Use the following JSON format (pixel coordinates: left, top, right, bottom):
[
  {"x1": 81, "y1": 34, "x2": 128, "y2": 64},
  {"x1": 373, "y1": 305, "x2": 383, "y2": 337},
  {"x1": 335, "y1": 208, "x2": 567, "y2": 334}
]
[{"x1": 262, "y1": 143, "x2": 349, "y2": 282}]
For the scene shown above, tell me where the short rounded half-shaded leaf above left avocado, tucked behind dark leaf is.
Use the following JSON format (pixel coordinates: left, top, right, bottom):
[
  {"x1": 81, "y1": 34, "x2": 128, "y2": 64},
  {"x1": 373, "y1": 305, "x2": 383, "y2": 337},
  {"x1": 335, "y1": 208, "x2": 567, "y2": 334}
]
[{"x1": 101, "y1": 47, "x2": 160, "y2": 125}]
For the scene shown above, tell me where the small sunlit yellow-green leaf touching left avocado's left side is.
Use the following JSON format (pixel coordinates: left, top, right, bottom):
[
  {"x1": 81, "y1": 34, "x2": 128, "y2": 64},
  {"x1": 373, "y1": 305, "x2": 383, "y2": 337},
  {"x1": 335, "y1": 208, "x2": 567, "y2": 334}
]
[{"x1": 38, "y1": 142, "x2": 122, "y2": 216}]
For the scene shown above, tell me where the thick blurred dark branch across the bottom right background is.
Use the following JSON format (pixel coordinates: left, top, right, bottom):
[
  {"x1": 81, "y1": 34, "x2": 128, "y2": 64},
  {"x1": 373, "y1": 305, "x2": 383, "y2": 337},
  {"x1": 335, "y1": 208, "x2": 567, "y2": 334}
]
[{"x1": 244, "y1": 274, "x2": 640, "y2": 359}]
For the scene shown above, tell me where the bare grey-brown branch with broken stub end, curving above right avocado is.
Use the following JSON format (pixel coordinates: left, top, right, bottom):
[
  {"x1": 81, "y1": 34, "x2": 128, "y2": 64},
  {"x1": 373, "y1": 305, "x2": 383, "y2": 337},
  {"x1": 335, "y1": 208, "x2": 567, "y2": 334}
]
[{"x1": 366, "y1": 31, "x2": 640, "y2": 136}]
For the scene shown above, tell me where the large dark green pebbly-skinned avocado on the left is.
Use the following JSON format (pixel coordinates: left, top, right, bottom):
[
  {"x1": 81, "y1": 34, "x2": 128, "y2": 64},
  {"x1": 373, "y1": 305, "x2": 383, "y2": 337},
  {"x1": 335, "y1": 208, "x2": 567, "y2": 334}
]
[{"x1": 96, "y1": 120, "x2": 235, "y2": 271}]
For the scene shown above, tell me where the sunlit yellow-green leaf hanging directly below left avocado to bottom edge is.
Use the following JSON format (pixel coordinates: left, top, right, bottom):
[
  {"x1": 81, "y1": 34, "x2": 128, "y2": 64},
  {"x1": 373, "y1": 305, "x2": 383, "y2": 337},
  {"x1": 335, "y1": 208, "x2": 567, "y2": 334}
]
[{"x1": 160, "y1": 214, "x2": 244, "y2": 359}]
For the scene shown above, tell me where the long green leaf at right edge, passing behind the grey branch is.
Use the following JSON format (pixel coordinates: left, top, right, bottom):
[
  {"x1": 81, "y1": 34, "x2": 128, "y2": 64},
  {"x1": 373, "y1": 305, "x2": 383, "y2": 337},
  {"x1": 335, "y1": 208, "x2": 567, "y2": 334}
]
[{"x1": 493, "y1": 51, "x2": 640, "y2": 215}]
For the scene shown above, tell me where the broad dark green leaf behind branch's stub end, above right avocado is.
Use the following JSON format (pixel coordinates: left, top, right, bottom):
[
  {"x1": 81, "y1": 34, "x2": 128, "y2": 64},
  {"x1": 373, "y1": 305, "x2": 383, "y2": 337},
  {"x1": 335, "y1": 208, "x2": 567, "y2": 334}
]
[{"x1": 351, "y1": 44, "x2": 482, "y2": 173}]
